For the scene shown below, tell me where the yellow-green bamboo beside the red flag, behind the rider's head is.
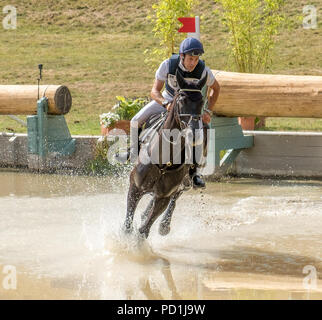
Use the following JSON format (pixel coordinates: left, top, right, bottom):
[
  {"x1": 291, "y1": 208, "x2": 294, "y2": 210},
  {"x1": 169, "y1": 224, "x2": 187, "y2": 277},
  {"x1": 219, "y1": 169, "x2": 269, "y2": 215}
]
[{"x1": 144, "y1": 0, "x2": 198, "y2": 70}]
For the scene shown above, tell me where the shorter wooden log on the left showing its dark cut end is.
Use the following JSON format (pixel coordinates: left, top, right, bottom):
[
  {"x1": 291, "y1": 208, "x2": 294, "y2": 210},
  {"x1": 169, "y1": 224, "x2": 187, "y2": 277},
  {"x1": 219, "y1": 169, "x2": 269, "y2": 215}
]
[{"x1": 0, "y1": 85, "x2": 72, "y2": 115}]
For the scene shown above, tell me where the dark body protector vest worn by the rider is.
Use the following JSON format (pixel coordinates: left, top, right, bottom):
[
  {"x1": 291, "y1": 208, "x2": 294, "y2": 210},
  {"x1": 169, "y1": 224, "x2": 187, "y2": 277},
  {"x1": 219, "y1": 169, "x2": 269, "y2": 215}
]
[{"x1": 165, "y1": 54, "x2": 205, "y2": 96}]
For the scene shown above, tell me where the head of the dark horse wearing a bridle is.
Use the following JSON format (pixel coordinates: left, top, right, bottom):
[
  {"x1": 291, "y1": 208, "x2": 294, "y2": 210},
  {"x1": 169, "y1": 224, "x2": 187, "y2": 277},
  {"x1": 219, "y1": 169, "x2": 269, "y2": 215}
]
[{"x1": 175, "y1": 70, "x2": 207, "y2": 145}]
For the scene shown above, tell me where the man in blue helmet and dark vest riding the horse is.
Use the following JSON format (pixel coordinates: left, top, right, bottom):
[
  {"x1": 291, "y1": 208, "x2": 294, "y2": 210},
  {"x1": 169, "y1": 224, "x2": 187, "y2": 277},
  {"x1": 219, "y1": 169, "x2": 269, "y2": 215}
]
[{"x1": 122, "y1": 37, "x2": 220, "y2": 187}]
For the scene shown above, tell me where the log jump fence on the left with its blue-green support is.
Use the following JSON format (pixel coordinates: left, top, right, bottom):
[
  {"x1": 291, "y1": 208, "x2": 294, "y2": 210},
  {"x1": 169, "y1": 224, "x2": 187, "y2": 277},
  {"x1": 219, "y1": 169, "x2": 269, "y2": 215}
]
[{"x1": 0, "y1": 85, "x2": 75, "y2": 158}]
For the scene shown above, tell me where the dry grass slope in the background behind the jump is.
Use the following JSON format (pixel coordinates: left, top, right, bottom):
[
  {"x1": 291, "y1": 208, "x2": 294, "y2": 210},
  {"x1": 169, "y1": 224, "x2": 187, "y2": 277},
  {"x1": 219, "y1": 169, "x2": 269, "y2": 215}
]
[{"x1": 0, "y1": 0, "x2": 322, "y2": 135}]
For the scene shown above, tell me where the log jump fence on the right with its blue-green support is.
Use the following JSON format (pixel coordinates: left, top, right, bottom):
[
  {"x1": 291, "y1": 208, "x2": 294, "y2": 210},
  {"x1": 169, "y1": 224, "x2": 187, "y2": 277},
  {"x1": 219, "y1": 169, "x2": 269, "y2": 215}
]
[{"x1": 205, "y1": 70, "x2": 322, "y2": 174}]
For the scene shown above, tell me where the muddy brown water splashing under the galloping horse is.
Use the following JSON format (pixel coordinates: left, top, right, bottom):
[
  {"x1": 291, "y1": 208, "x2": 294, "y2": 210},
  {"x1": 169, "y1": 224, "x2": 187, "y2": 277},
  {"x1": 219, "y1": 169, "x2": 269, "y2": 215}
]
[{"x1": 0, "y1": 171, "x2": 322, "y2": 299}]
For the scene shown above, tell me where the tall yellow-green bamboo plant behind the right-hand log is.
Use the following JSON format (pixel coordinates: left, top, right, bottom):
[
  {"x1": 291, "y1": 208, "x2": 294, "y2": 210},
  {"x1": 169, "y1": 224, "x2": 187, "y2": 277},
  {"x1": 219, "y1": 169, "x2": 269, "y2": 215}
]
[{"x1": 215, "y1": 0, "x2": 285, "y2": 73}]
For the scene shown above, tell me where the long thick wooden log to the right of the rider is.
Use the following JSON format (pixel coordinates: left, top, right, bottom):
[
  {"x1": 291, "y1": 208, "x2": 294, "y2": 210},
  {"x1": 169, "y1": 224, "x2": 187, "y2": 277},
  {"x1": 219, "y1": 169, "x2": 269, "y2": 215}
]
[{"x1": 212, "y1": 70, "x2": 322, "y2": 118}]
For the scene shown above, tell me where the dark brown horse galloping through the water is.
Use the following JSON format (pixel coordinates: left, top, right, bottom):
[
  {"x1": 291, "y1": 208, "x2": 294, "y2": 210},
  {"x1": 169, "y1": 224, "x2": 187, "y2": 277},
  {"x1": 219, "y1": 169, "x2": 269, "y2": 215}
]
[{"x1": 123, "y1": 71, "x2": 207, "y2": 238}]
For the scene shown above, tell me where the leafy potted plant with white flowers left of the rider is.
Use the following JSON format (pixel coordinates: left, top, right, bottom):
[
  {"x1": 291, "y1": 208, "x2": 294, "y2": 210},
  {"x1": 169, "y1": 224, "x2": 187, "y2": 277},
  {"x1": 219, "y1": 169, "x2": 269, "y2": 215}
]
[{"x1": 112, "y1": 96, "x2": 148, "y2": 120}]
